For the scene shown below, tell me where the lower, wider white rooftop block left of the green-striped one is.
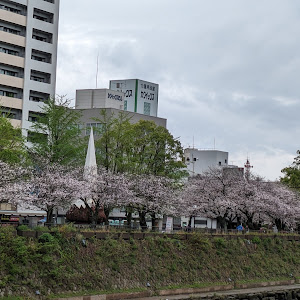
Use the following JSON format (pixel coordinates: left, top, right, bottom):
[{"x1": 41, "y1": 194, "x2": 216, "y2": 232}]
[{"x1": 75, "y1": 89, "x2": 124, "y2": 110}]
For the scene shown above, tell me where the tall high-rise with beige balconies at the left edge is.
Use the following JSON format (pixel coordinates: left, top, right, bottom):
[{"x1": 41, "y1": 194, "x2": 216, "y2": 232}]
[{"x1": 0, "y1": 0, "x2": 60, "y2": 135}]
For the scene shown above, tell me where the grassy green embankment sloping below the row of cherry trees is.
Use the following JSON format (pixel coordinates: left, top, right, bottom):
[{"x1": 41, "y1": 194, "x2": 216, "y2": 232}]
[{"x1": 0, "y1": 227, "x2": 300, "y2": 297}]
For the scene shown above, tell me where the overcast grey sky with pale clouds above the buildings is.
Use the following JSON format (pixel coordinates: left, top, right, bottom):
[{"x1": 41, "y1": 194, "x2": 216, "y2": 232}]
[{"x1": 57, "y1": 0, "x2": 300, "y2": 180}]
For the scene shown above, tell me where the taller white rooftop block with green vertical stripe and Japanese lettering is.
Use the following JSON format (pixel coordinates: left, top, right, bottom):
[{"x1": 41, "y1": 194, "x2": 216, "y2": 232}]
[{"x1": 109, "y1": 79, "x2": 159, "y2": 117}]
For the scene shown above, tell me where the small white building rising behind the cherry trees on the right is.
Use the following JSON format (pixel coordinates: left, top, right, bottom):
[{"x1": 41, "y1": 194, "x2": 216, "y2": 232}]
[{"x1": 184, "y1": 148, "x2": 228, "y2": 176}]
